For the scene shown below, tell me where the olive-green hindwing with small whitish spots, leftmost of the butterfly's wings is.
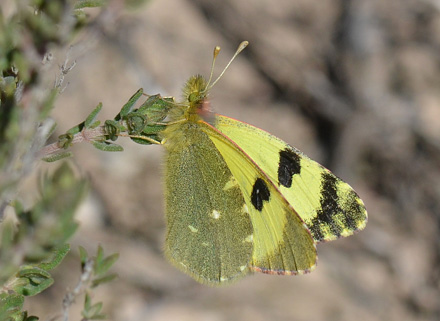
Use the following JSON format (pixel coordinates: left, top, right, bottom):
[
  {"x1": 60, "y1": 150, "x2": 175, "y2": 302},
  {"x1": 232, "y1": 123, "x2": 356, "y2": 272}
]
[{"x1": 165, "y1": 123, "x2": 253, "y2": 285}]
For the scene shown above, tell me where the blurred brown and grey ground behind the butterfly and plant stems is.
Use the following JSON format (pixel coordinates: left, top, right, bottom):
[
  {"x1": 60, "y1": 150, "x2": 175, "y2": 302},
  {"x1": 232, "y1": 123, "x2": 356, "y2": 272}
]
[{"x1": 10, "y1": 0, "x2": 440, "y2": 321}]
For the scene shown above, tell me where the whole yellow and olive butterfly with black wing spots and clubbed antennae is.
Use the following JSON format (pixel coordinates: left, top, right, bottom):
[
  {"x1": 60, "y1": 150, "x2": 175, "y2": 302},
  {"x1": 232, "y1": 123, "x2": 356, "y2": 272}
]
[{"x1": 144, "y1": 42, "x2": 367, "y2": 285}]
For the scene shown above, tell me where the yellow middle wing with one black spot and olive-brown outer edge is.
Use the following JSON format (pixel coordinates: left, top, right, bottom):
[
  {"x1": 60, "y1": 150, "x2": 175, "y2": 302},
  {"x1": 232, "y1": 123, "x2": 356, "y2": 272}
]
[{"x1": 204, "y1": 123, "x2": 316, "y2": 274}]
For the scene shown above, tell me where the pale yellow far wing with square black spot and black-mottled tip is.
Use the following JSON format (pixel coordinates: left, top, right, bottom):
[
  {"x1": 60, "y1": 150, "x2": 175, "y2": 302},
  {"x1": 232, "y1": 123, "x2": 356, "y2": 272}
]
[{"x1": 214, "y1": 115, "x2": 367, "y2": 242}]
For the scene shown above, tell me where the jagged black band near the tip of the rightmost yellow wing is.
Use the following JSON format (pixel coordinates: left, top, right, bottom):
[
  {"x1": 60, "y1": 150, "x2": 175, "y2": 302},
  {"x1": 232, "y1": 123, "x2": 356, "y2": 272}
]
[{"x1": 311, "y1": 172, "x2": 345, "y2": 240}]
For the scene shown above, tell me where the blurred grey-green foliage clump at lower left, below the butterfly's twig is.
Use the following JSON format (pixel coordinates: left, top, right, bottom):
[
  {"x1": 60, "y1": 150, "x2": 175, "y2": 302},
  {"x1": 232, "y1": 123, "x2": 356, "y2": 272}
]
[{"x1": 0, "y1": 163, "x2": 87, "y2": 320}]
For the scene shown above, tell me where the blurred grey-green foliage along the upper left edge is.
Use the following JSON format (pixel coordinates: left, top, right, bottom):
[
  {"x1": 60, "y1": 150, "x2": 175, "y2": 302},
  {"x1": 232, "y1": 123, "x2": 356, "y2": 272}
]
[{"x1": 0, "y1": 0, "x2": 90, "y2": 217}]
